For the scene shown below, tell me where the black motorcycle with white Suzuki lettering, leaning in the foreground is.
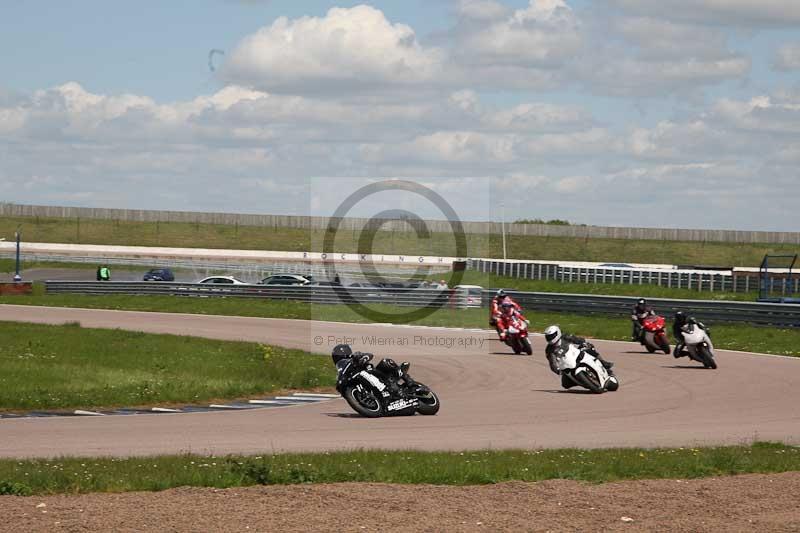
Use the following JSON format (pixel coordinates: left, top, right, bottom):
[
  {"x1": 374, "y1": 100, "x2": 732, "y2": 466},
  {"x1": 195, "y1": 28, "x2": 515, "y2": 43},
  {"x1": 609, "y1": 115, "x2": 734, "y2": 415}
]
[{"x1": 336, "y1": 352, "x2": 441, "y2": 418}]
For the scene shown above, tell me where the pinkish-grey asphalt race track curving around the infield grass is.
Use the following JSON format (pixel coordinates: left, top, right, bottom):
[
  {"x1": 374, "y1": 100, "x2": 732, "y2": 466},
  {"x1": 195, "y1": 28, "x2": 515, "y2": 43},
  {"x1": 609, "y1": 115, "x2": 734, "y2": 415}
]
[{"x1": 0, "y1": 305, "x2": 800, "y2": 457}]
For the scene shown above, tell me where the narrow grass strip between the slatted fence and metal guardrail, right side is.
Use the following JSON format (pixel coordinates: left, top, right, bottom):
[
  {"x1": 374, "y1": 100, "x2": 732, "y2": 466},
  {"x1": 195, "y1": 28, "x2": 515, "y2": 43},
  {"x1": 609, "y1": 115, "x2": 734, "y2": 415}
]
[{"x1": 450, "y1": 270, "x2": 758, "y2": 302}]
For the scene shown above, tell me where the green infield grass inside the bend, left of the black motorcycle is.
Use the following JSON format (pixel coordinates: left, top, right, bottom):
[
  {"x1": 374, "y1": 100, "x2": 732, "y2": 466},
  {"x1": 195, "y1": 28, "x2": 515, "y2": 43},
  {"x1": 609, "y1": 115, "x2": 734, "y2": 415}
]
[{"x1": 0, "y1": 322, "x2": 336, "y2": 411}]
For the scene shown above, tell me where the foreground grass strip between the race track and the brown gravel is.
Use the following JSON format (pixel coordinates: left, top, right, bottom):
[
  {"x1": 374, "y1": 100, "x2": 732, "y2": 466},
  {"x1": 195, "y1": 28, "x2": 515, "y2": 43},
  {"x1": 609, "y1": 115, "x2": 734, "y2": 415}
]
[{"x1": 0, "y1": 443, "x2": 800, "y2": 495}]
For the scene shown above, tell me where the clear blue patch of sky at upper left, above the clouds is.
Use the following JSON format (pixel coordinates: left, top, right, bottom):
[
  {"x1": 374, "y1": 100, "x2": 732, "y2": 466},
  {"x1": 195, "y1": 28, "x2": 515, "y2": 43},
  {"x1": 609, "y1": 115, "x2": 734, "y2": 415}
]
[{"x1": 0, "y1": 0, "x2": 462, "y2": 102}]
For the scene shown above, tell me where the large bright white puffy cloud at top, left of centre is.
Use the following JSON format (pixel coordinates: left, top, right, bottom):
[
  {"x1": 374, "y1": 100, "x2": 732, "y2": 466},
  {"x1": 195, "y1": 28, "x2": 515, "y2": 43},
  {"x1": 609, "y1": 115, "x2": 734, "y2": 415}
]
[{"x1": 222, "y1": 5, "x2": 443, "y2": 93}]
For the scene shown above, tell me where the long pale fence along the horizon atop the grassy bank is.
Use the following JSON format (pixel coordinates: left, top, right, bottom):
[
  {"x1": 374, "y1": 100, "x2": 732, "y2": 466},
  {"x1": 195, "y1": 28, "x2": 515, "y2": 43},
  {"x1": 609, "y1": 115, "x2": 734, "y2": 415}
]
[{"x1": 0, "y1": 203, "x2": 800, "y2": 245}]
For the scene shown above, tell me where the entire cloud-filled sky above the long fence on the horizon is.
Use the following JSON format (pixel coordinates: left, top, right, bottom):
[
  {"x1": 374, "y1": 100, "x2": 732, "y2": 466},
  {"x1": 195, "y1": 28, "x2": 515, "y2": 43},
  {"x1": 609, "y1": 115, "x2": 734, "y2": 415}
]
[{"x1": 0, "y1": 0, "x2": 800, "y2": 231}]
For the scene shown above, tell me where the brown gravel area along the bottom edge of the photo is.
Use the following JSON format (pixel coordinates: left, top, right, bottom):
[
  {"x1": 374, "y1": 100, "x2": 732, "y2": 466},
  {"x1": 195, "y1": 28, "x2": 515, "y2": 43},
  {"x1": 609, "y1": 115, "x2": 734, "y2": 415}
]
[{"x1": 0, "y1": 472, "x2": 800, "y2": 533}]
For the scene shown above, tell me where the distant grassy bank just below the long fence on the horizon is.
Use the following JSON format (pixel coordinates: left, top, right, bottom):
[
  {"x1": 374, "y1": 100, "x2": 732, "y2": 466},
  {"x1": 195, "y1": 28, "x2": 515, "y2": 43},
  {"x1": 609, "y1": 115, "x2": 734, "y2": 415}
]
[{"x1": 0, "y1": 217, "x2": 798, "y2": 266}]
